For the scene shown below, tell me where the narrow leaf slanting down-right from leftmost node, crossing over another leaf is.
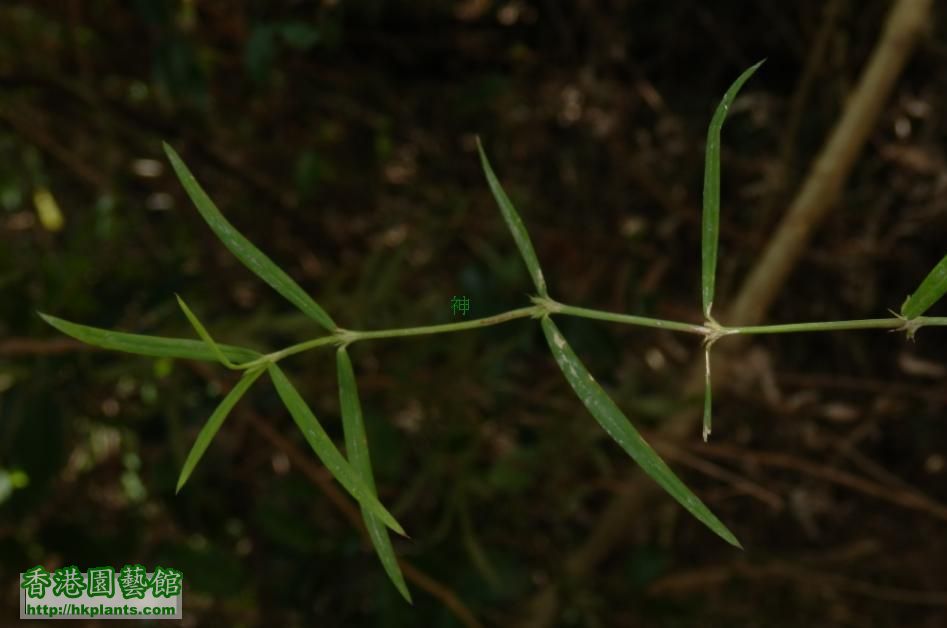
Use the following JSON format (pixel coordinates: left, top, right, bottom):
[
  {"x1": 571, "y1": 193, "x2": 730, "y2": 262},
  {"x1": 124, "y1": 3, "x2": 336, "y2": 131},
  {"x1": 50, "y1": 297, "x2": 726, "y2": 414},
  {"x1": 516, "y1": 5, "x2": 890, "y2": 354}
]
[{"x1": 267, "y1": 362, "x2": 406, "y2": 536}]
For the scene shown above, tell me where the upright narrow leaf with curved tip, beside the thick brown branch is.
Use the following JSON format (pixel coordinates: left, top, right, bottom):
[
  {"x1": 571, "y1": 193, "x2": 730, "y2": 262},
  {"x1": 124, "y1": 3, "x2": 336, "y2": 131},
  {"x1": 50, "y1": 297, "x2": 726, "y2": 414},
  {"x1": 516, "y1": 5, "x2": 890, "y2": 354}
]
[{"x1": 701, "y1": 59, "x2": 765, "y2": 319}]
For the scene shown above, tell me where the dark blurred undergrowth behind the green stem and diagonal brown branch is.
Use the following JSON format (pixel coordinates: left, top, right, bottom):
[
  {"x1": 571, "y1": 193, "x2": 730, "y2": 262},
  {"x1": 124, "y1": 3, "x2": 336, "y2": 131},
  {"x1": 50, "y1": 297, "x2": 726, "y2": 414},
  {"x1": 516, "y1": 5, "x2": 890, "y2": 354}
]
[{"x1": 0, "y1": 0, "x2": 947, "y2": 627}]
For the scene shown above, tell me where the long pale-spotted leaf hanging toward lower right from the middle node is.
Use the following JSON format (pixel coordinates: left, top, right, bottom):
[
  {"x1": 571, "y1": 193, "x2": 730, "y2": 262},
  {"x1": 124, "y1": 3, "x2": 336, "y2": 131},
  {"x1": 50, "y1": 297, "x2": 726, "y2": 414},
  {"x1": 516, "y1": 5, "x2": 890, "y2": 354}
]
[{"x1": 542, "y1": 316, "x2": 742, "y2": 549}]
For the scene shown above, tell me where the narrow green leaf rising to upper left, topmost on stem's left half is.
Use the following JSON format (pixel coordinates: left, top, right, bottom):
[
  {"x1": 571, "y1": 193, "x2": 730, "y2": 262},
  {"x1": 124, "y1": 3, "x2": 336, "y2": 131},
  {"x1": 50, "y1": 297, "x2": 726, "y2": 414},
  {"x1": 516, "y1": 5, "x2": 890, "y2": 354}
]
[{"x1": 163, "y1": 143, "x2": 337, "y2": 331}]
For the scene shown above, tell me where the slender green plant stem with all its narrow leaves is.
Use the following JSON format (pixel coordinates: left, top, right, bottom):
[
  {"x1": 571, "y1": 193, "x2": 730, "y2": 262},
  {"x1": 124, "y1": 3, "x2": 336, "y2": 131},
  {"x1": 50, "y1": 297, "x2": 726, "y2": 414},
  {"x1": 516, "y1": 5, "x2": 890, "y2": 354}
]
[{"x1": 41, "y1": 62, "x2": 947, "y2": 600}]
